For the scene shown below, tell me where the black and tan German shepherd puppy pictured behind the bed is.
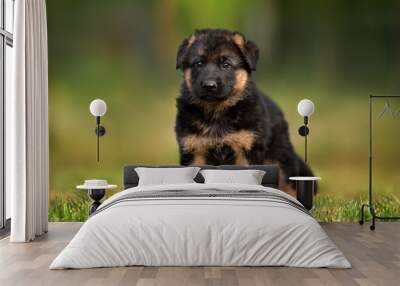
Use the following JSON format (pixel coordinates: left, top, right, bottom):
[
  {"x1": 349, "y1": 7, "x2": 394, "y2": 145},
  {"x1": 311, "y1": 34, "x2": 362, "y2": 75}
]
[{"x1": 175, "y1": 29, "x2": 313, "y2": 194}]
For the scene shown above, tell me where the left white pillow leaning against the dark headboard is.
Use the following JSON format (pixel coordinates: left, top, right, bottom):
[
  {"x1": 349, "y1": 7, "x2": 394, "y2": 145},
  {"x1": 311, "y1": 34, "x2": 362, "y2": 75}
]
[{"x1": 135, "y1": 167, "x2": 200, "y2": 186}]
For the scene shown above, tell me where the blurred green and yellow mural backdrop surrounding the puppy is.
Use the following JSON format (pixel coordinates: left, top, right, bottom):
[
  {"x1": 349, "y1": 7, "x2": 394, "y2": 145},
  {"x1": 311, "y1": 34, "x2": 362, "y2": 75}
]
[{"x1": 47, "y1": 0, "x2": 400, "y2": 220}]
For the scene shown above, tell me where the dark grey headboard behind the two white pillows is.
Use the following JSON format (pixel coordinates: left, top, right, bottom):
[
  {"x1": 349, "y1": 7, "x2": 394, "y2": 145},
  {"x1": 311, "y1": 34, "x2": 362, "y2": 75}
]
[{"x1": 124, "y1": 165, "x2": 279, "y2": 189}]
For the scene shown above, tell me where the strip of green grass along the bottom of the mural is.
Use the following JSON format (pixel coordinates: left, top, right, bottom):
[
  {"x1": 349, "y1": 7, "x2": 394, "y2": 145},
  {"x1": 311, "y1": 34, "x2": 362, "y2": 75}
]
[{"x1": 49, "y1": 195, "x2": 400, "y2": 222}]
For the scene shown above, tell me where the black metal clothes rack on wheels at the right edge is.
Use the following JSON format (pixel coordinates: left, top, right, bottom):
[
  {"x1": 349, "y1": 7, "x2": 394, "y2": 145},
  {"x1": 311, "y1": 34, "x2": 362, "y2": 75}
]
[{"x1": 359, "y1": 95, "x2": 400, "y2": 230}]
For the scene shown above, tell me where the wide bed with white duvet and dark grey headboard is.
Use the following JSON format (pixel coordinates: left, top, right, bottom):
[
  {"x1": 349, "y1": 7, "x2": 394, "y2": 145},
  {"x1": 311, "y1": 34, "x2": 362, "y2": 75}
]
[{"x1": 50, "y1": 165, "x2": 351, "y2": 269}]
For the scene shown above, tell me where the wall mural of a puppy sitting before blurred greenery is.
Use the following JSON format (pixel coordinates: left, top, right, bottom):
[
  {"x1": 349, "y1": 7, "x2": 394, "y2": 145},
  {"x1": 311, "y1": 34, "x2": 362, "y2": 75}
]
[{"x1": 47, "y1": 0, "x2": 400, "y2": 221}]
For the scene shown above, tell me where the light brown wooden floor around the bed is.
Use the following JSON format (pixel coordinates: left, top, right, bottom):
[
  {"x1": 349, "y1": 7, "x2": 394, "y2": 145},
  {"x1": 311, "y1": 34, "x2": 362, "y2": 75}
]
[{"x1": 0, "y1": 223, "x2": 400, "y2": 286}]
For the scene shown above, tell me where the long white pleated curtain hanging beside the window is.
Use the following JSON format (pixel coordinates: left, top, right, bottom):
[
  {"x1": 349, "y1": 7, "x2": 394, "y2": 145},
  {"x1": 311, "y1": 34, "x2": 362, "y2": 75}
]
[{"x1": 6, "y1": 0, "x2": 49, "y2": 242}]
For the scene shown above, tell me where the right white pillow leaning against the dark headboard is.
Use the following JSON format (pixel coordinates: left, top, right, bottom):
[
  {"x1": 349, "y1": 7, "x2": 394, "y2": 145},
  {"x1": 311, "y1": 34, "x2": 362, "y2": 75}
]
[{"x1": 200, "y1": 170, "x2": 265, "y2": 185}]
